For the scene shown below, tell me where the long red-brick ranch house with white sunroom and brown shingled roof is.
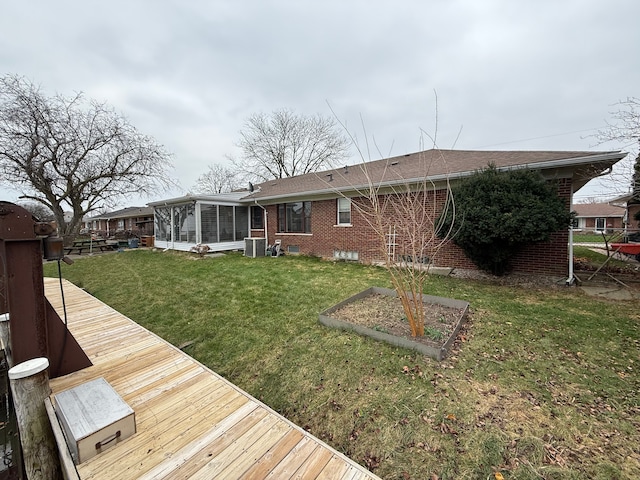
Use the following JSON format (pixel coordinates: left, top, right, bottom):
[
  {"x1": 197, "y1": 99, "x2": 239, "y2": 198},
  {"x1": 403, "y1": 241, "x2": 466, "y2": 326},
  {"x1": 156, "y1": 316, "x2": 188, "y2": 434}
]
[{"x1": 149, "y1": 150, "x2": 626, "y2": 275}]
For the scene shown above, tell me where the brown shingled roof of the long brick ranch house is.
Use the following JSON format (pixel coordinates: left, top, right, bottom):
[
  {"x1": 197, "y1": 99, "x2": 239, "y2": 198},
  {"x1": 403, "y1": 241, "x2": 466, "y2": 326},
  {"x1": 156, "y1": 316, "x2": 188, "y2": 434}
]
[{"x1": 244, "y1": 150, "x2": 626, "y2": 201}]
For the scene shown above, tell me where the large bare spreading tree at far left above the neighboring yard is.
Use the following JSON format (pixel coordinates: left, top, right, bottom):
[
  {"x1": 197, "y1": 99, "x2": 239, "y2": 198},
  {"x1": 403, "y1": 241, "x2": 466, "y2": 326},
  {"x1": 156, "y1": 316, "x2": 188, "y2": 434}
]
[{"x1": 0, "y1": 75, "x2": 171, "y2": 237}]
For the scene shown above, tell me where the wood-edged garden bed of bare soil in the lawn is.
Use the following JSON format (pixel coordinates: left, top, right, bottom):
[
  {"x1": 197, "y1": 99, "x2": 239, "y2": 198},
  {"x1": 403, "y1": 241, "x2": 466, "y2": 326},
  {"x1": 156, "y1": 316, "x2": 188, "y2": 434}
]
[{"x1": 319, "y1": 287, "x2": 469, "y2": 360}]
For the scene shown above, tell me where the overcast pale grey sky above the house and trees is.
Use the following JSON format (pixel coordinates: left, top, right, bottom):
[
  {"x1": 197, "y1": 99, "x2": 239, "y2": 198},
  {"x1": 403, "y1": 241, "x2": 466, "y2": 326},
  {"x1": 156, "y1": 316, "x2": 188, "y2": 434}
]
[{"x1": 0, "y1": 0, "x2": 640, "y2": 207}]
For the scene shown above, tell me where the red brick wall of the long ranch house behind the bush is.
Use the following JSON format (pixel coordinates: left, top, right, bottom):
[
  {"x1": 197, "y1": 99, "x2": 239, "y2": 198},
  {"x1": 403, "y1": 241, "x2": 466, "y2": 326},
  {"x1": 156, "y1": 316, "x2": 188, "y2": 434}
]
[{"x1": 262, "y1": 179, "x2": 571, "y2": 275}]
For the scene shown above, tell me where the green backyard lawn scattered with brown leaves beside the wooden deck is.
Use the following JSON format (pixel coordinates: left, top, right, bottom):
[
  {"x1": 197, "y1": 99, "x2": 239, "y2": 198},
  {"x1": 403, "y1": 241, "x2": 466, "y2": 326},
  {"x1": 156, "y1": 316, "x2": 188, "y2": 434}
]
[{"x1": 45, "y1": 251, "x2": 640, "y2": 480}]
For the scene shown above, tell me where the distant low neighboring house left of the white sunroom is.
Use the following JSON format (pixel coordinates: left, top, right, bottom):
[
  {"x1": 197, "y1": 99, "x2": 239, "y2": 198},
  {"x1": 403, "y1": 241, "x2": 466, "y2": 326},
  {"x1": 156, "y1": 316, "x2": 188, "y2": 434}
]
[{"x1": 85, "y1": 207, "x2": 153, "y2": 237}]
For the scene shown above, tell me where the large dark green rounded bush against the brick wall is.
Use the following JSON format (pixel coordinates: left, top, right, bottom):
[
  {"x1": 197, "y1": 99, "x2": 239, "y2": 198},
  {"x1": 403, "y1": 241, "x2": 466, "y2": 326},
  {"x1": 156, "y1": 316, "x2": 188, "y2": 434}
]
[{"x1": 440, "y1": 165, "x2": 572, "y2": 275}]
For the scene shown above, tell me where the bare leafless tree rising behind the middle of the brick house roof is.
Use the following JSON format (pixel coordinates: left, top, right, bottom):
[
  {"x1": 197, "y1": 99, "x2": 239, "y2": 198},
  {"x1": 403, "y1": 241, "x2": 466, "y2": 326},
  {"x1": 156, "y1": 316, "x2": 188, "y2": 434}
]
[{"x1": 238, "y1": 110, "x2": 351, "y2": 181}]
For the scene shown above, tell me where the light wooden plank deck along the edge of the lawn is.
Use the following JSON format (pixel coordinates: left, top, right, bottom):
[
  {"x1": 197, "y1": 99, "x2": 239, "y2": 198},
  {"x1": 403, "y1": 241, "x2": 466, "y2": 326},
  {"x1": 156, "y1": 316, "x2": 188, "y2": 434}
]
[{"x1": 45, "y1": 279, "x2": 378, "y2": 480}]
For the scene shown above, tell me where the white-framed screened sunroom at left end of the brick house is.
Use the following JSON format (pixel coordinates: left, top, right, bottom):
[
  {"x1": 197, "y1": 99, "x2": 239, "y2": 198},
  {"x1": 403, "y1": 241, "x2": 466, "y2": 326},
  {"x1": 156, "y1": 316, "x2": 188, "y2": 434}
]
[{"x1": 149, "y1": 191, "x2": 250, "y2": 252}]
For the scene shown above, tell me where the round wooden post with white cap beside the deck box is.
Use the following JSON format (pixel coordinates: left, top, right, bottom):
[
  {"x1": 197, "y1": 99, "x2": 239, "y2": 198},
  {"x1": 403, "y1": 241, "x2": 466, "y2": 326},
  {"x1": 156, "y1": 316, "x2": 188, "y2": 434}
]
[{"x1": 9, "y1": 357, "x2": 62, "y2": 480}]
